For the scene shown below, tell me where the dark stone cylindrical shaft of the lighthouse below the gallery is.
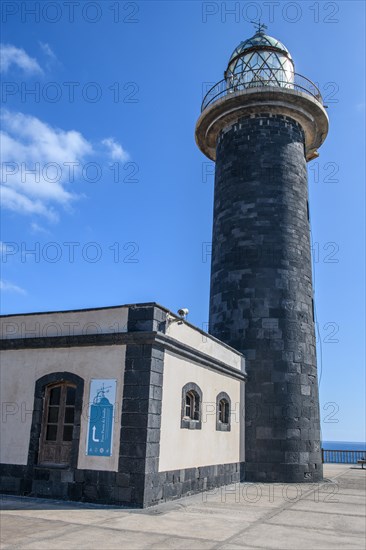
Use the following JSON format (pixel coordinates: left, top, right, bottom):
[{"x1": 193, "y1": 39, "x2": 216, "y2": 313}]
[{"x1": 210, "y1": 113, "x2": 322, "y2": 482}]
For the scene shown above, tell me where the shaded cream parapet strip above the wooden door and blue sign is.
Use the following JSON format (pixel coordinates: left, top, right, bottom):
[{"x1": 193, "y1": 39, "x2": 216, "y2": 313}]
[{"x1": 0, "y1": 307, "x2": 128, "y2": 338}]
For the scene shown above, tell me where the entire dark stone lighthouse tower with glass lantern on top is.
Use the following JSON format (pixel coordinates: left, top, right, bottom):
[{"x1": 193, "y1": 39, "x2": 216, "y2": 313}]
[{"x1": 196, "y1": 25, "x2": 328, "y2": 482}]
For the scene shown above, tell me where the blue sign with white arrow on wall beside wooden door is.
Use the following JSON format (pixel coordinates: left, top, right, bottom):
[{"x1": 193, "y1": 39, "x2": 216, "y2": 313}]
[{"x1": 86, "y1": 380, "x2": 117, "y2": 456}]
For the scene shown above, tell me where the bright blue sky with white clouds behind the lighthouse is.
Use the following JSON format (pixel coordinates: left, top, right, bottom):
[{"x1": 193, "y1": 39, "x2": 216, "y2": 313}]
[{"x1": 1, "y1": 1, "x2": 365, "y2": 441}]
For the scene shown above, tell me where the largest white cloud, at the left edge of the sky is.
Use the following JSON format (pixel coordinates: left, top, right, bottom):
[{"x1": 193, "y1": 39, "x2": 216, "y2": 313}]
[{"x1": 0, "y1": 110, "x2": 94, "y2": 221}]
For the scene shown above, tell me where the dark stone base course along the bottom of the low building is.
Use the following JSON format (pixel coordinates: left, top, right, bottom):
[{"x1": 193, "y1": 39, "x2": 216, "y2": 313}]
[{"x1": 0, "y1": 462, "x2": 245, "y2": 508}]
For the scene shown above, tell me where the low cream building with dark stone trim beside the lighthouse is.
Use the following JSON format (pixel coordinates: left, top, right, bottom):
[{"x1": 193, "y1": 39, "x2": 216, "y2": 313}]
[{"x1": 1, "y1": 303, "x2": 246, "y2": 507}]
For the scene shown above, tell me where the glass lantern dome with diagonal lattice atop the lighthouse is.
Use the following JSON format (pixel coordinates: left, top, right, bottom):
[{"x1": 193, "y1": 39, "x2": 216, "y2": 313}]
[{"x1": 224, "y1": 23, "x2": 295, "y2": 91}]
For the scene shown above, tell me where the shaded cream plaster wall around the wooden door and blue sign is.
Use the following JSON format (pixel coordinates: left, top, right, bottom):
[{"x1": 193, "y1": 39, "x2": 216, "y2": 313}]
[{"x1": 0, "y1": 345, "x2": 126, "y2": 471}]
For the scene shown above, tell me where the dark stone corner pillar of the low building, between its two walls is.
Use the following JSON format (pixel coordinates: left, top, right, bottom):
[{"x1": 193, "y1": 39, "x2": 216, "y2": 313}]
[{"x1": 118, "y1": 307, "x2": 166, "y2": 507}]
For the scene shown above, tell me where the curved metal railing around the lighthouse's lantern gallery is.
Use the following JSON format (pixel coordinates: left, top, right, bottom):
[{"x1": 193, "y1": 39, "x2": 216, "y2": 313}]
[{"x1": 201, "y1": 70, "x2": 323, "y2": 112}]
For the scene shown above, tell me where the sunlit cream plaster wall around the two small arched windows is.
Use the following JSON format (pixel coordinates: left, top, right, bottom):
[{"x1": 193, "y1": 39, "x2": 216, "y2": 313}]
[{"x1": 159, "y1": 352, "x2": 244, "y2": 472}]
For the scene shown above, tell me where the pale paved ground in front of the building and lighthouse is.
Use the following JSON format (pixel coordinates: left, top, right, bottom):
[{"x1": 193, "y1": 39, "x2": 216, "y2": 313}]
[{"x1": 1, "y1": 464, "x2": 366, "y2": 550}]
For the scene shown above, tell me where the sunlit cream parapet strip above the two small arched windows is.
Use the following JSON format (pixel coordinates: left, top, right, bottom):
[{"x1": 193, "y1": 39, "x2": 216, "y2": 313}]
[{"x1": 166, "y1": 321, "x2": 242, "y2": 370}]
